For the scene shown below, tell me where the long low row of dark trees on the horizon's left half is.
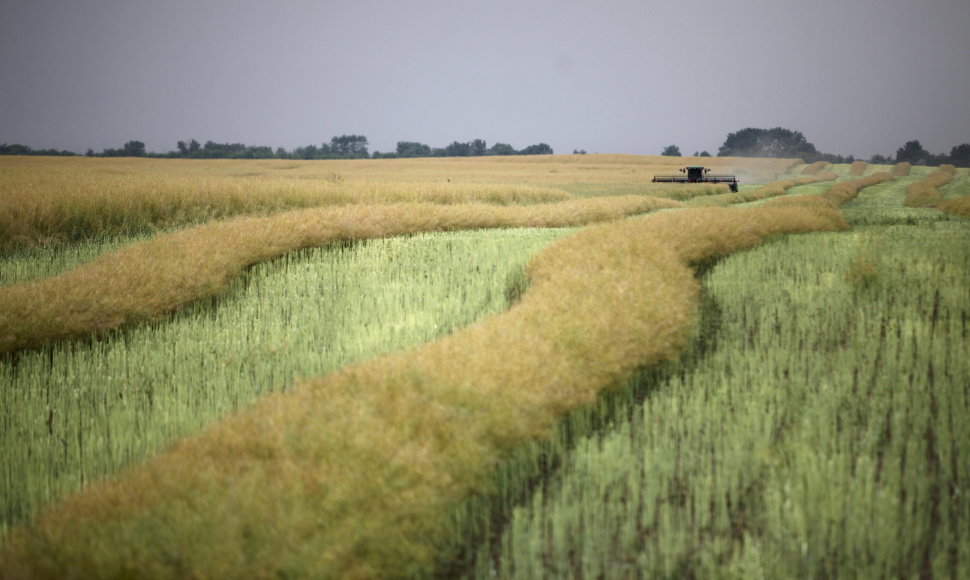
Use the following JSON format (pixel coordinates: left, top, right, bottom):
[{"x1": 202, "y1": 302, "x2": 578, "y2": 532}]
[{"x1": 0, "y1": 135, "x2": 553, "y2": 159}]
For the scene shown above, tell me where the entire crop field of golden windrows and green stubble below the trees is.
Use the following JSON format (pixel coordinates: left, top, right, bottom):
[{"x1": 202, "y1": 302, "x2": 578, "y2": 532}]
[{"x1": 0, "y1": 155, "x2": 970, "y2": 578}]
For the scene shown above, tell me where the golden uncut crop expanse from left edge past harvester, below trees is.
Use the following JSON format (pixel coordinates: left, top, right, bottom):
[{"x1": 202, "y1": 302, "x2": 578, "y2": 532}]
[{"x1": 0, "y1": 155, "x2": 797, "y2": 252}]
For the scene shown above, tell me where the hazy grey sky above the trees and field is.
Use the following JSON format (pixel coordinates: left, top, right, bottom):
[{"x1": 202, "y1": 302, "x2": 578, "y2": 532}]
[{"x1": 0, "y1": 0, "x2": 970, "y2": 158}]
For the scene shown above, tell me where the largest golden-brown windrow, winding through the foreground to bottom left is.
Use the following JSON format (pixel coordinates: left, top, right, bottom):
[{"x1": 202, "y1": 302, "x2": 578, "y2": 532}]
[{"x1": 0, "y1": 198, "x2": 848, "y2": 578}]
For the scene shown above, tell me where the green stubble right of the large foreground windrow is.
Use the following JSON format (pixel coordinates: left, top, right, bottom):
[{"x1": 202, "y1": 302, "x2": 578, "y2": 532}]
[{"x1": 466, "y1": 176, "x2": 970, "y2": 578}]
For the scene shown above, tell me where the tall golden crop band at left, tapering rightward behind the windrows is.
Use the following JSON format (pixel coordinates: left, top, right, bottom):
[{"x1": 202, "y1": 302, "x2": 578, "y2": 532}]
[{"x1": 0, "y1": 165, "x2": 573, "y2": 252}]
